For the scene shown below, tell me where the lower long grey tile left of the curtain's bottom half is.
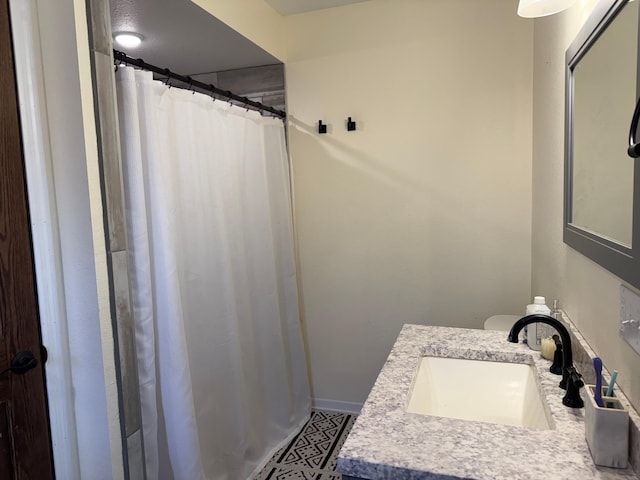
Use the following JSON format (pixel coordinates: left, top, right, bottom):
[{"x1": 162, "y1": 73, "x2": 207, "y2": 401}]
[{"x1": 111, "y1": 251, "x2": 142, "y2": 437}]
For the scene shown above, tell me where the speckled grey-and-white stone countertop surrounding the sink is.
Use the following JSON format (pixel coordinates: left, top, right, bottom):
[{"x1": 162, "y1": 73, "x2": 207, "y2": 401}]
[{"x1": 338, "y1": 325, "x2": 637, "y2": 480}]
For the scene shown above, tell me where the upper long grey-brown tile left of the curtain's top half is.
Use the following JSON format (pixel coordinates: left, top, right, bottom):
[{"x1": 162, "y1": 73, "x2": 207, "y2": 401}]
[{"x1": 94, "y1": 53, "x2": 127, "y2": 252}]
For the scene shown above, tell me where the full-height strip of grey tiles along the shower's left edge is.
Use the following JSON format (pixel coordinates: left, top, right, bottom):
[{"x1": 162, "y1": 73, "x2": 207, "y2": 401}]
[{"x1": 85, "y1": 0, "x2": 145, "y2": 474}]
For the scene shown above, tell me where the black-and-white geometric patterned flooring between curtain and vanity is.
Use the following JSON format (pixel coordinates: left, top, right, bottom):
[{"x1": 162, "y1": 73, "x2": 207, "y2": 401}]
[{"x1": 256, "y1": 410, "x2": 356, "y2": 480}]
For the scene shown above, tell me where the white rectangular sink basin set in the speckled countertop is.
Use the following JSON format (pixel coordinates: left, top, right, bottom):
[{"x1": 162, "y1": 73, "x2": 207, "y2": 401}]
[{"x1": 407, "y1": 356, "x2": 551, "y2": 429}]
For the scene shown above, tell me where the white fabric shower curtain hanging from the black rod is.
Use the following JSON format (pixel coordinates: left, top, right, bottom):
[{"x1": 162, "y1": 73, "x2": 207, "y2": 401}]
[{"x1": 116, "y1": 68, "x2": 310, "y2": 480}]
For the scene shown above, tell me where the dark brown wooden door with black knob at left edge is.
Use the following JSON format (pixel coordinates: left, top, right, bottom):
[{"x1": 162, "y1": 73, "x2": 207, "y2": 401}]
[{"x1": 0, "y1": 0, "x2": 54, "y2": 480}]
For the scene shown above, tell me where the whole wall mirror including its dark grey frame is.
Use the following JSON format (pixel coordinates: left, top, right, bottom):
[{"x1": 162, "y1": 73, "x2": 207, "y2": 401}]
[{"x1": 564, "y1": 0, "x2": 640, "y2": 286}]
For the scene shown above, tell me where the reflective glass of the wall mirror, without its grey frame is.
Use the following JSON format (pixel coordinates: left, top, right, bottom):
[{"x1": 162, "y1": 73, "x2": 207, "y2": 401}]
[{"x1": 571, "y1": 2, "x2": 638, "y2": 247}]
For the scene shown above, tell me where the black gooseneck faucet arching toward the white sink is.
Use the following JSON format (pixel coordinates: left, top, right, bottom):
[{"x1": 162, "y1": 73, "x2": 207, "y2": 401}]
[{"x1": 507, "y1": 314, "x2": 584, "y2": 408}]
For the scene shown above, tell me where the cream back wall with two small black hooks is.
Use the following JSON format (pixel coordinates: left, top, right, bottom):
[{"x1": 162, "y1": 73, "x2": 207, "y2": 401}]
[{"x1": 285, "y1": 0, "x2": 533, "y2": 408}]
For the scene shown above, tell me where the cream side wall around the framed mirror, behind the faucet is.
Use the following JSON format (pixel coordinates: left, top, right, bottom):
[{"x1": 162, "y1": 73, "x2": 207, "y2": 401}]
[{"x1": 532, "y1": 0, "x2": 640, "y2": 409}]
